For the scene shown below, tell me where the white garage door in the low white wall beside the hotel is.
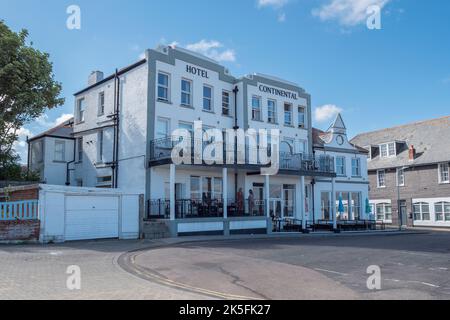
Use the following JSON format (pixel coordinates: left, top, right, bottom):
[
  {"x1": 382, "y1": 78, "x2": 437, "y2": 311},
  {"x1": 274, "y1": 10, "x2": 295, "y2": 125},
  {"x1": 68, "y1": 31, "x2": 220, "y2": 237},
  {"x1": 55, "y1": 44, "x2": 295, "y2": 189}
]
[{"x1": 65, "y1": 196, "x2": 119, "y2": 240}]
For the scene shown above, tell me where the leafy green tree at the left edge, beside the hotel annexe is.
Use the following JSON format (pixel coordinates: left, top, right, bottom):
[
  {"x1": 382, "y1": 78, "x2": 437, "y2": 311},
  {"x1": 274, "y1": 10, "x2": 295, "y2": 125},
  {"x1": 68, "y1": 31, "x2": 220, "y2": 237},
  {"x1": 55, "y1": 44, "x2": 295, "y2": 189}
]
[{"x1": 0, "y1": 20, "x2": 64, "y2": 176}]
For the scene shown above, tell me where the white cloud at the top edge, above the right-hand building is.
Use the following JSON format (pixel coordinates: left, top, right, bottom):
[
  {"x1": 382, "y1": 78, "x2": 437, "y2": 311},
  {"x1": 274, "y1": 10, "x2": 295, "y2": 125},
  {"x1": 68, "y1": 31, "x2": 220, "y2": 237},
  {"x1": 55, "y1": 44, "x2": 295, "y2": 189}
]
[{"x1": 312, "y1": 0, "x2": 391, "y2": 27}]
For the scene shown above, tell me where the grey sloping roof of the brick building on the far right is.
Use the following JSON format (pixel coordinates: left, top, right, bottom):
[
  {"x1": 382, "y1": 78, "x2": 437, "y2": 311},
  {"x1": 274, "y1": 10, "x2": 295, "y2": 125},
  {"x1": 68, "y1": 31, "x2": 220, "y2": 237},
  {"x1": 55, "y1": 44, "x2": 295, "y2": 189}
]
[{"x1": 351, "y1": 116, "x2": 450, "y2": 170}]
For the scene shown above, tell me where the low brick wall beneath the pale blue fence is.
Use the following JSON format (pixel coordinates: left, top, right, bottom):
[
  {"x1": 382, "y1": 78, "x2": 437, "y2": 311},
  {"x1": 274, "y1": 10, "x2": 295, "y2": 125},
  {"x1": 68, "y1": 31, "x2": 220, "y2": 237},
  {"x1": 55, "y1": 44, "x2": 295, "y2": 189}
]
[{"x1": 0, "y1": 220, "x2": 40, "y2": 241}]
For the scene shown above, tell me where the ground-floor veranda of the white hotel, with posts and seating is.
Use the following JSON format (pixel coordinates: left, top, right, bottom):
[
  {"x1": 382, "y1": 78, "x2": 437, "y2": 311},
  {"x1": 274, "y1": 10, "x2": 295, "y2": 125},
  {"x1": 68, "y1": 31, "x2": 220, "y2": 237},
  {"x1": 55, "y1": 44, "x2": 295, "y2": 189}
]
[{"x1": 146, "y1": 164, "x2": 372, "y2": 234}]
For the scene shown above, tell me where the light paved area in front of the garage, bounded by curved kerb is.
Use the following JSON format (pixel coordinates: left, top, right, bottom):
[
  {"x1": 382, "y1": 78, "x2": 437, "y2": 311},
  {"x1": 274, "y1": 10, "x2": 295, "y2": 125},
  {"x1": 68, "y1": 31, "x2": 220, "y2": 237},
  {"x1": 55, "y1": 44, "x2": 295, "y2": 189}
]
[{"x1": 0, "y1": 240, "x2": 205, "y2": 300}]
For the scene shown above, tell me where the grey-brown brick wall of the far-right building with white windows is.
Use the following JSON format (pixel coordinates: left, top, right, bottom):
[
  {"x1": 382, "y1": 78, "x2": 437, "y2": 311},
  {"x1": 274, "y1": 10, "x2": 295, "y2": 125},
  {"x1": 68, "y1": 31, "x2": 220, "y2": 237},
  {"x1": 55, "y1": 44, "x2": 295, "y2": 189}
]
[{"x1": 369, "y1": 165, "x2": 450, "y2": 226}]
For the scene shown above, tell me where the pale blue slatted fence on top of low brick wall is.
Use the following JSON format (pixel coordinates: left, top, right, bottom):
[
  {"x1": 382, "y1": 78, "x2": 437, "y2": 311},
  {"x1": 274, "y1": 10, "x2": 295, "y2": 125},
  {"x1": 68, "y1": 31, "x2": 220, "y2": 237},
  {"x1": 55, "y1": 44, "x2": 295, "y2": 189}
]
[{"x1": 0, "y1": 200, "x2": 39, "y2": 221}]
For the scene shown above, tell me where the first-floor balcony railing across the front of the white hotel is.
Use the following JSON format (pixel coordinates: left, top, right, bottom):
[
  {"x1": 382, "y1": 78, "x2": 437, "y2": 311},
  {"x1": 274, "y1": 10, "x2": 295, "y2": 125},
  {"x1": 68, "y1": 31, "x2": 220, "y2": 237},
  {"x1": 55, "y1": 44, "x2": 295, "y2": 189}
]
[{"x1": 150, "y1": 137, "x2": 335, "y2": 174}]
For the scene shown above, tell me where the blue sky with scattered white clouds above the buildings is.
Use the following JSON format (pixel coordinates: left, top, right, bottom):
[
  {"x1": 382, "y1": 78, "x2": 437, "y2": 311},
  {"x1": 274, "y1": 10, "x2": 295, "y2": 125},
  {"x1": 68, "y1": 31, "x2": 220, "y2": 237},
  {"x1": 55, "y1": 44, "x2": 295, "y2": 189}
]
[{"x1": 0, "y1": 0, "x2": 450, "y2": 162}]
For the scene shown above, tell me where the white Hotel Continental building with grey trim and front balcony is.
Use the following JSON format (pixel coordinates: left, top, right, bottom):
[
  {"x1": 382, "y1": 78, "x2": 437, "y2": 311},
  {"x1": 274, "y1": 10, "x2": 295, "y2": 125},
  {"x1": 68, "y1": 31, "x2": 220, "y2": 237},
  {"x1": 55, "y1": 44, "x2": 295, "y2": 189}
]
[{"x1": 30, "y1": 46, "x2": 368, "y2": 236}]
